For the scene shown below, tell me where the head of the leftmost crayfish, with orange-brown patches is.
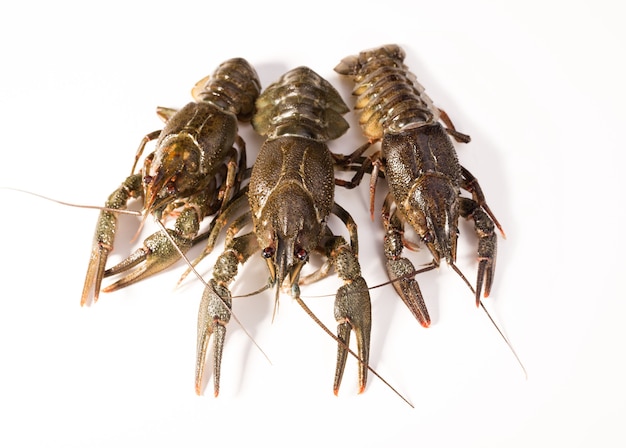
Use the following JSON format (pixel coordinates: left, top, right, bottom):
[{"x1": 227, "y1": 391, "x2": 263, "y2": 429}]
[{"x1": 143, "y1": 134, "x2": 200, "y2": 214}]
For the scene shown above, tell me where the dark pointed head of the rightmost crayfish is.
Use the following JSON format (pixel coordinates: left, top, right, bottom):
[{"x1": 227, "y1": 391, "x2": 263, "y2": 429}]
[{"x1": 401, "y1": 173, "x2": 459, "y2": 264}]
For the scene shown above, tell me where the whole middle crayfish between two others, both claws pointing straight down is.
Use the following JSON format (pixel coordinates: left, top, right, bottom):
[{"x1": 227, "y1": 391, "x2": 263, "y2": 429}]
[{"x1": 196, "y1": 67, "x2": 371, "y2": 395}]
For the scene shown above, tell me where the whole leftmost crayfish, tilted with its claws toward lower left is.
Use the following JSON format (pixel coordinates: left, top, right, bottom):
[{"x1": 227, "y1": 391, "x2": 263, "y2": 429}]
[{"x1": 81, "y1": 58, "x2": 261, "y2": 305}]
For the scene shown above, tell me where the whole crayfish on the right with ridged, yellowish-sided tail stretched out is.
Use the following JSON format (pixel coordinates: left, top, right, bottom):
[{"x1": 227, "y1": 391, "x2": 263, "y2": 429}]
[{"x1": 335, "y1": 45, "x2": 504, "y2": 326}]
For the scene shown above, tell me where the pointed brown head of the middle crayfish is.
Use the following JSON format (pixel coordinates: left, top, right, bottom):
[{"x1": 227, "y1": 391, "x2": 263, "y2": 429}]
[{"x1": 254, "y1": 183, "x2": 325, "y2": 297}]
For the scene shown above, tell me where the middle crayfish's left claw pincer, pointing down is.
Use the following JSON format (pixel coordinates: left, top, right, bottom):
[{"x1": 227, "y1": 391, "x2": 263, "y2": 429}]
[{"x1": 195, "y1": 279, "x2": 232, "y2": 397}]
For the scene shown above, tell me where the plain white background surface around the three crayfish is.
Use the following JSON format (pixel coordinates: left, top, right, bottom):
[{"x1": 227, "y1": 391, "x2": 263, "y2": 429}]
[{"x1": 0, "y1": 1, "x2": 626, "y2": 447}]
